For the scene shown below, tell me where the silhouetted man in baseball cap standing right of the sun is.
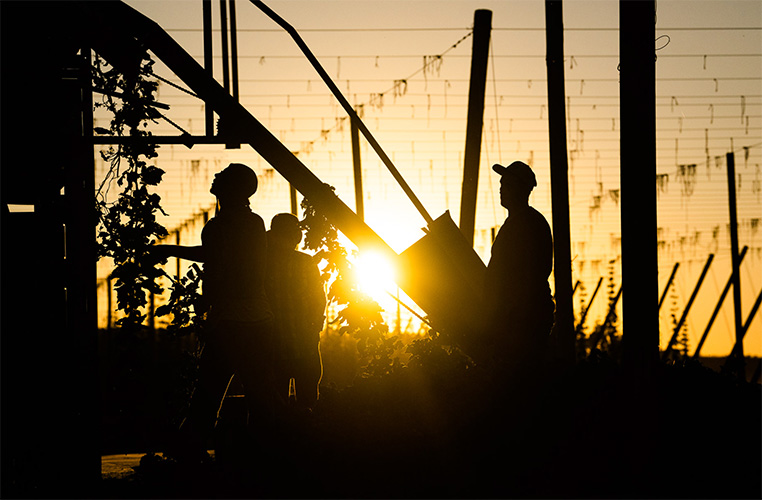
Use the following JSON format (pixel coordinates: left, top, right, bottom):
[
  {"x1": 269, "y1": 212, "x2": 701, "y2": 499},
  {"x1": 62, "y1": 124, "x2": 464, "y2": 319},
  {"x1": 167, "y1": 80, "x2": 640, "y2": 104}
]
[{"x1": 485, "y1": 161, "x2": 555, "y2": 384}]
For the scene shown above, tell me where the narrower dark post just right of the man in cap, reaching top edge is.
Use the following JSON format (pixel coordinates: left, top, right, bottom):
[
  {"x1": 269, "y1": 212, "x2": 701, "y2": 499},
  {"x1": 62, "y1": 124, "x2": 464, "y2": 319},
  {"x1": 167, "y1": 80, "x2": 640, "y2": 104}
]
[{"x1": 545, "y1": 0, "x2": 576, "y2": 364}]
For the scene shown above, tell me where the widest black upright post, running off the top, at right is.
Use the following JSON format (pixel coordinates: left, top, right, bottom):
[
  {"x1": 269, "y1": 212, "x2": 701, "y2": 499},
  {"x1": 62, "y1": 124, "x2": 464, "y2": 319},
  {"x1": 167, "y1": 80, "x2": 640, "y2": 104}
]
[{"x1": 619, "y1": 0, "x2": 659, "y2": 379}]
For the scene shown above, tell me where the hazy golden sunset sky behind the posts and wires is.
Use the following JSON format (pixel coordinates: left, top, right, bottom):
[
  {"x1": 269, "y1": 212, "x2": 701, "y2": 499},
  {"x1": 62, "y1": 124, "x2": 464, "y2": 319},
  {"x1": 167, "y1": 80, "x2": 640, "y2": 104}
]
[{"x1": 98, "y1": 0, "x2": 762, "y2": 355}]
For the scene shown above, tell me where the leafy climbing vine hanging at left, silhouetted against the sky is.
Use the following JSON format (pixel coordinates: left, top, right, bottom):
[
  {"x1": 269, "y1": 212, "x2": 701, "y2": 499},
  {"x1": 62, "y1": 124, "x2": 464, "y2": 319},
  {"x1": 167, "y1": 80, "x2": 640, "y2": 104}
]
[{"x1": 92, "y1": 54, "x2": 167, "y2": 331}]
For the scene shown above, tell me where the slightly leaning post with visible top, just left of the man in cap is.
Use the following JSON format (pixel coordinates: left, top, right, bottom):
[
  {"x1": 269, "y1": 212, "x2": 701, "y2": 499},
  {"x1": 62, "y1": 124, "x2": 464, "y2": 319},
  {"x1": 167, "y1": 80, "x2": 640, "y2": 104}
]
[{"x1": 459, "y1": 9, "x2": 492, "y2": 246}]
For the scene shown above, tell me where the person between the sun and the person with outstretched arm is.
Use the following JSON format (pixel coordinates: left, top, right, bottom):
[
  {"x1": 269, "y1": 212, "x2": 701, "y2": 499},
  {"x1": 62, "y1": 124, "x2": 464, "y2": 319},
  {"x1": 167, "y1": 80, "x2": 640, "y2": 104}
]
[{"x1": 265, "y1": 213, "x2": 326, "y2": 408}]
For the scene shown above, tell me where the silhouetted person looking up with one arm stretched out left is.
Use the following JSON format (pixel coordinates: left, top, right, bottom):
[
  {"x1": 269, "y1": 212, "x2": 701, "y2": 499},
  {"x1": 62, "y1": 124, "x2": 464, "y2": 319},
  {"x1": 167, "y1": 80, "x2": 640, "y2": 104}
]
[{"x1": 153, "y1": 163, "x2": 274, "y2": 461}]
